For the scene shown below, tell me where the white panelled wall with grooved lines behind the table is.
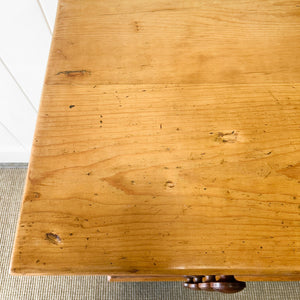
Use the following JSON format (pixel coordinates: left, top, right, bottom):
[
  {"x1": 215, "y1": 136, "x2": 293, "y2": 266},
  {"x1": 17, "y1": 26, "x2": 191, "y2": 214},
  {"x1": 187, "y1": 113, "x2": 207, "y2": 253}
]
[{"x1": 0, "y1": 0, "x2": 58, "y2": 163}]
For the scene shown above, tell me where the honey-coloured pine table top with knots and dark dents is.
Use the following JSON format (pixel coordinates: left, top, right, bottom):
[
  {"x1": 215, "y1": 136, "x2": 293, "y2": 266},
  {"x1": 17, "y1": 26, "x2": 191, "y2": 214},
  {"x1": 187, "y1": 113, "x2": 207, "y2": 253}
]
[{"x1": 11, "y1": 0, "x2": 300, "y2": 278}]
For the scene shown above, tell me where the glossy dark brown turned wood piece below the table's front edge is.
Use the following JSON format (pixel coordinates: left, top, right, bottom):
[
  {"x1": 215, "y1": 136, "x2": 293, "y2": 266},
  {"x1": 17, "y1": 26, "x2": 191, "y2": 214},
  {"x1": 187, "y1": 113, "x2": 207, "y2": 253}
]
[{"x1": 184, "y1": 275, "x2": 246, "y2": 293}]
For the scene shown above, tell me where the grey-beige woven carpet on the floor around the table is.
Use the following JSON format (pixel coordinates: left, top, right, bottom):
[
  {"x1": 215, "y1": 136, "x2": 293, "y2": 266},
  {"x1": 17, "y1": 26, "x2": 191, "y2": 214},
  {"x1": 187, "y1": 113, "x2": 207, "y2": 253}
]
[{"x1": 0, "y1": 165, "x2": 300, "y2": 300}]
